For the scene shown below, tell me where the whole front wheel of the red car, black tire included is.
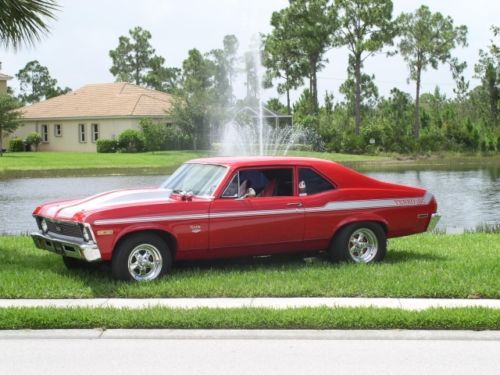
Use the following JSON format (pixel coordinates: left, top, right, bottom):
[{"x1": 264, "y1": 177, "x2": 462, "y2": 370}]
[{"x1": 111, "y1": 233, "x2": 172, "y2": 281}]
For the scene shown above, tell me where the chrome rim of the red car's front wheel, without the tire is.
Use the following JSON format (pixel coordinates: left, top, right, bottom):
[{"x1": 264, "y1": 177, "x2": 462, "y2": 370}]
[{"x1": 128, "y1": 244, "x2": 163, "y2": 281}]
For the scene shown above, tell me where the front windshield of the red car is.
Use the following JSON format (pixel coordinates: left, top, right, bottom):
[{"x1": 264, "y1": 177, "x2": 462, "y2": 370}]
[{"x1": 162, "y1": 163, "x2": 226, "y2": 196}]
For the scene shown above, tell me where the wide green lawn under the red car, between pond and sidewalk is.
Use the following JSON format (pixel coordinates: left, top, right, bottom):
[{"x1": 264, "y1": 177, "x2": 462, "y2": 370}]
[{"x1": 0, "y1": 233, "x2": 500, "y2": 300}]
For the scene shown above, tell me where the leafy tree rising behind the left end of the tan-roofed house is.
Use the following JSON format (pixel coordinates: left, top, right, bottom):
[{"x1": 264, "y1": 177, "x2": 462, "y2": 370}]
[{"x1": 16, "y1": 60, "x2": 71, "y2": 104}]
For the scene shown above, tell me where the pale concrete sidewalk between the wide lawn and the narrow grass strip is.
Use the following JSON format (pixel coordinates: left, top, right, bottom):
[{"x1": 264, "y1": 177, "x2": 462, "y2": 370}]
[{"x1": 0, "y1": 297, "x2": 500, "y2": 311}]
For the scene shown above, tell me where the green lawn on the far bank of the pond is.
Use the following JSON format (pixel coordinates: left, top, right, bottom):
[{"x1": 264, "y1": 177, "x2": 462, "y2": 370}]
[{"x1": 0, "y1": 151, "x2": 388, "y2": 176}]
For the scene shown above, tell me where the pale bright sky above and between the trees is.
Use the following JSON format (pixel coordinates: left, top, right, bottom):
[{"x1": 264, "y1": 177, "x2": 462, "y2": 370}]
[{"x1": 0, "y1": 0, "x2": 500, "y2": 102}]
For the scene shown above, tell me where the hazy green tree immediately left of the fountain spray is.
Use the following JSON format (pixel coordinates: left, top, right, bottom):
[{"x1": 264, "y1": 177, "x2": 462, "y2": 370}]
[{"x1": 168, "y1": 49, "x2": 213, "y2": 150}]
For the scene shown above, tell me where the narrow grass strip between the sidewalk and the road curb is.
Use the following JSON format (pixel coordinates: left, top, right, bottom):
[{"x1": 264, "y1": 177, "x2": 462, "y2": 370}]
[{"x1": 0, "y1": 308, "x2": 500, "y2": 330}]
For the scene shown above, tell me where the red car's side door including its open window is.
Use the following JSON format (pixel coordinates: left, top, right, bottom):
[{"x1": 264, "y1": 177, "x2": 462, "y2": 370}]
[{"x1": 209, "y1": 167, "x2": 304, "y2": 256}]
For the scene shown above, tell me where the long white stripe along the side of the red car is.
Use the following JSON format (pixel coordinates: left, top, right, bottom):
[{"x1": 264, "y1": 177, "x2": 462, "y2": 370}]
[{"x1": 94, "y1": 192, "x2": 433, "y2": 225}]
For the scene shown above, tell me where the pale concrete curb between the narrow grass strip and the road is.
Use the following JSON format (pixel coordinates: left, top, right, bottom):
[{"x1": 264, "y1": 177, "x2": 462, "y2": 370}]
[{"x1": 0, "y1": 329, "x2": 500, "y2": 341}]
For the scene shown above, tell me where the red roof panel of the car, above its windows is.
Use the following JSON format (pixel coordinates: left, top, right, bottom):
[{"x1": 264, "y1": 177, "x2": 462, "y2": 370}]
[{"x1": 188, "y1": 156, "x2": 337, "y2": 167}]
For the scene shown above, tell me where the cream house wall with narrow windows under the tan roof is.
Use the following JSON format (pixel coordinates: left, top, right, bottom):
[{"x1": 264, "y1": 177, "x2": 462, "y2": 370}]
[{"x1": 3, "y1": 118, "x2": 148, "y2": 152}]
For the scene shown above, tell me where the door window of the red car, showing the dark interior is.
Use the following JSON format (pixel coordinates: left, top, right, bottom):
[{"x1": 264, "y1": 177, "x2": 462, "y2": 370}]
[{"x1": 222, "y1": 168, "x2": 293, "y2": 198}]
